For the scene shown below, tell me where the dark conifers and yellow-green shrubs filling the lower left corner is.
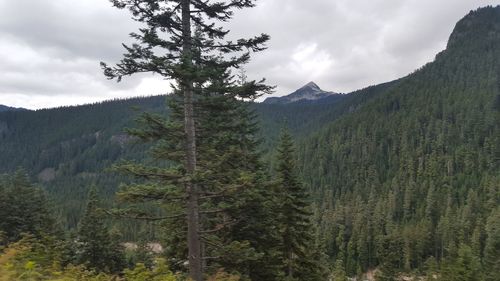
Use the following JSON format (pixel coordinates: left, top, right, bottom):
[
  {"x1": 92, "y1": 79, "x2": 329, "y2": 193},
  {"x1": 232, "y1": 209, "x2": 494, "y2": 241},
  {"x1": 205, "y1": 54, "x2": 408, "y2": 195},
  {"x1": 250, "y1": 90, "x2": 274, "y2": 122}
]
[{"x1": 0, "y1": 170, "x2": 197, "y2": 281}]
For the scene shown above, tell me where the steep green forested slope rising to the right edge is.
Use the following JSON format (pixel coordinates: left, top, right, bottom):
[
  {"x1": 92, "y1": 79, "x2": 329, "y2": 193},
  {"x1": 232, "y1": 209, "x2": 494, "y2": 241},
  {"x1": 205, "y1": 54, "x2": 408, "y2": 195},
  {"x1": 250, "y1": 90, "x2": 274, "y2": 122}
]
[{"x1": 299, "y1": 7, "x2": 500, "y2": 280}]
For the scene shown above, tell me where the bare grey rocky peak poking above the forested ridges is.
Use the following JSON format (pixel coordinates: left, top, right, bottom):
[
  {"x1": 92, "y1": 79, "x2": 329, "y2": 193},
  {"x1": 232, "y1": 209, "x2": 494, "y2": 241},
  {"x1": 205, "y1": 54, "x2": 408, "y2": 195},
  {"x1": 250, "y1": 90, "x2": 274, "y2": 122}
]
[{"x1": 264, "y1": 82, "x2": 342, "y2": 104}]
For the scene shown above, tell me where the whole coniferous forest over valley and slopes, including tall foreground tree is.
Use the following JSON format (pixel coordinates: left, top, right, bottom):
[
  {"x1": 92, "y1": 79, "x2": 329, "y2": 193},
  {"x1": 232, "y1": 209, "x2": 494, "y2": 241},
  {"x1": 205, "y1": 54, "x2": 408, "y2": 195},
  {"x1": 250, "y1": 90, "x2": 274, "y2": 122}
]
[{"x1": 0, "y1": 0, "x2": 500, "y2": 281}]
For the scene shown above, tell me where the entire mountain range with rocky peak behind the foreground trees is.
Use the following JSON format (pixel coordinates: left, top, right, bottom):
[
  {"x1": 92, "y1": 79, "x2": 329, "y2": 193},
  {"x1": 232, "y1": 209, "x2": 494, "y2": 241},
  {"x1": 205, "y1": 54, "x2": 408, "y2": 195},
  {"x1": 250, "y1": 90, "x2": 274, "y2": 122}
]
[{"x1": 0, "y1": 6, "x2": 500, "y2": 280}]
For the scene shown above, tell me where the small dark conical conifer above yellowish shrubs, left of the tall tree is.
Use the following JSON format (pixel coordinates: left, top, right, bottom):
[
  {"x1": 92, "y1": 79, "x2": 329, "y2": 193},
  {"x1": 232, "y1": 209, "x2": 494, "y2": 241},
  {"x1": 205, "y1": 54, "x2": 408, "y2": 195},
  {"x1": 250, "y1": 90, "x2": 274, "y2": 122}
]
[{"x1": 76, "y1": 187, "x2": 125, "y2": 272}]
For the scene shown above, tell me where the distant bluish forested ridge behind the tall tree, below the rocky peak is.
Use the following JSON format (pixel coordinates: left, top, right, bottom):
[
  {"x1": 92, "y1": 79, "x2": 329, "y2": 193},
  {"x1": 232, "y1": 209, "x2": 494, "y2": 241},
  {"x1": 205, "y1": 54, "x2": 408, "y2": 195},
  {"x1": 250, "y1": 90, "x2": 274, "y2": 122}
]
[{"x1": 0, "y1": 81, "x2": 376, "y2": 232}]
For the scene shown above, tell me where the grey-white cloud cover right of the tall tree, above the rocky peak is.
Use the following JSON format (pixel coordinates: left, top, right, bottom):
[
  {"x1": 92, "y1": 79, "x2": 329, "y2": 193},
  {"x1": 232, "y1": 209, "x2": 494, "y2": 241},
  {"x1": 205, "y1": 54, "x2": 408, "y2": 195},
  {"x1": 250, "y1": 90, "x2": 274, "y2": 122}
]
[{"x1": 228, "y1": 0, "x2": 500, "y2": 95}]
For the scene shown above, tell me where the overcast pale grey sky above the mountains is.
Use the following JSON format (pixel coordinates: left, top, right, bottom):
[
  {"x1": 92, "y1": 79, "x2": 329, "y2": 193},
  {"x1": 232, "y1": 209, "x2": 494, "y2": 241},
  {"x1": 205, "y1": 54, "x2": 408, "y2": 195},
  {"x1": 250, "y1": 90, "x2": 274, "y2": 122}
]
[{"x1": 0, "y1": 0, "x2": 500, "y2": 109}]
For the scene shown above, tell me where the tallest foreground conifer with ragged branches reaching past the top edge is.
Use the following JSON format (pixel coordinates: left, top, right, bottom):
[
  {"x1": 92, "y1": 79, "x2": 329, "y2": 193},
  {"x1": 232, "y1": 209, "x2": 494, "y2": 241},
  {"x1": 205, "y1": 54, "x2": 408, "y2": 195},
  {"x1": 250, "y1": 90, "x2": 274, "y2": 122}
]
[{"x1": 102, "y1": 0, "x2": 276, "y2": 281}]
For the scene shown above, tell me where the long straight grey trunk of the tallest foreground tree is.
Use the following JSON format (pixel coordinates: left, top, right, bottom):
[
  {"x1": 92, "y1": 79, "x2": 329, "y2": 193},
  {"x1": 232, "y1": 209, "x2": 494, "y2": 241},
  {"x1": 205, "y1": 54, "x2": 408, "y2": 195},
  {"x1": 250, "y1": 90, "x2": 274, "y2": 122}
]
[{"x1": 181, "y1": 0, "x2": 203, "y2": 281}]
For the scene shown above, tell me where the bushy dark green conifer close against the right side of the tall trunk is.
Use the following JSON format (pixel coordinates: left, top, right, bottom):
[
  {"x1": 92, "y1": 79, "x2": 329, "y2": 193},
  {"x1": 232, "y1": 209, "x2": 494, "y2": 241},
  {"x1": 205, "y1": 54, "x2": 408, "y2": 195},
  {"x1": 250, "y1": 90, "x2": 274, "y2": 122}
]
[{"x1": 200, "y1": 90, "x2": 280, "y2": 280}]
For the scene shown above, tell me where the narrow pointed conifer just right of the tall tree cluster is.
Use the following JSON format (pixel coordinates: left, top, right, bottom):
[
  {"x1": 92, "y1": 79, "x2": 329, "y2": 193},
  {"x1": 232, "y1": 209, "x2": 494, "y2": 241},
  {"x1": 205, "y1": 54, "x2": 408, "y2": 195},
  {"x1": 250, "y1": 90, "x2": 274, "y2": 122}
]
[{"x1": 276, "y1": 130, "x2": 325, "y2": 280}]
